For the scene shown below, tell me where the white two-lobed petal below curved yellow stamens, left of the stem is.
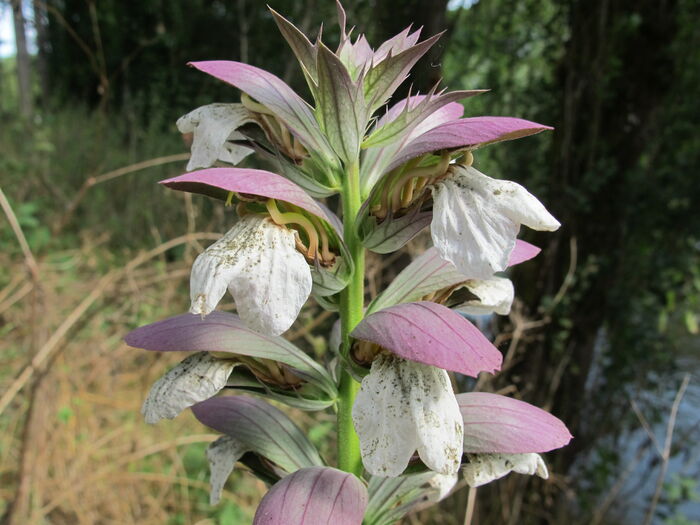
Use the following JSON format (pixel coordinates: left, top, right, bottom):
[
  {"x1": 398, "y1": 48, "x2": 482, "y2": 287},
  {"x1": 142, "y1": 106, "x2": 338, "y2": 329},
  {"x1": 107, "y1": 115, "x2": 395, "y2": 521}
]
[{"x1": 190, "y1": 215, "x2": 312, "y2": 335}]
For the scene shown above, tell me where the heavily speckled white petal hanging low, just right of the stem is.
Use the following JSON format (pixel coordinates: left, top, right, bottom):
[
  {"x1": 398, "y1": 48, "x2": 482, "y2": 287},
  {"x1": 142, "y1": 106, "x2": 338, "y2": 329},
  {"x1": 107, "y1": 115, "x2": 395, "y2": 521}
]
[{"x1": 352, "y1": 354, "x2": 463, "y2": 477}]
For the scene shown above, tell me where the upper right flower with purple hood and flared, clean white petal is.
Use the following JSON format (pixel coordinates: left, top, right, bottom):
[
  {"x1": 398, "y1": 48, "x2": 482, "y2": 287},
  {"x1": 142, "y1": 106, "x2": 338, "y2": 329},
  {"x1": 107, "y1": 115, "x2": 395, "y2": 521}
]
[{"x1": 358, "y1": 108, "x2": 559, "y2": 279}]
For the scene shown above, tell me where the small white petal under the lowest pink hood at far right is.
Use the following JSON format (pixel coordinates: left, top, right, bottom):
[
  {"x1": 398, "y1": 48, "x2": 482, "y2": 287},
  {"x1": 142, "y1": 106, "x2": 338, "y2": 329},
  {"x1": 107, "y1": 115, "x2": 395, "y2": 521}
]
[{"x1": 462, "y1": 452, "x2": 549, "y2": 487}]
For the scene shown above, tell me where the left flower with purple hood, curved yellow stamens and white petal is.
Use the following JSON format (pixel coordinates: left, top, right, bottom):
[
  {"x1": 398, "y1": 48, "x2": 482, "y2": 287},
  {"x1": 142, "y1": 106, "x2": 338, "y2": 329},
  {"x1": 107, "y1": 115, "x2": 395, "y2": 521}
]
[{"x1": 162, "y1": 168, "x2": 352, "y2": 335}]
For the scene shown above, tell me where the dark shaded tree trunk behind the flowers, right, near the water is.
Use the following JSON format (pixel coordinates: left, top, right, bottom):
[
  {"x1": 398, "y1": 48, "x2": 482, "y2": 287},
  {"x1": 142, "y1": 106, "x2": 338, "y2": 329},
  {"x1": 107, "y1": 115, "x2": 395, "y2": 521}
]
[{"x1": 494, "y1": 0, "x2": 676, "y2": 523}]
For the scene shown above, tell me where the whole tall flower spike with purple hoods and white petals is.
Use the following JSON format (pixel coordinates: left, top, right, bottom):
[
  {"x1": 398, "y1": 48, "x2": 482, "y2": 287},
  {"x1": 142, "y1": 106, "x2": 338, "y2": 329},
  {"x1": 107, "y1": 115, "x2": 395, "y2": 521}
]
[{"x1": 125, "y1": 4, "x2": 571, "y2": 525}]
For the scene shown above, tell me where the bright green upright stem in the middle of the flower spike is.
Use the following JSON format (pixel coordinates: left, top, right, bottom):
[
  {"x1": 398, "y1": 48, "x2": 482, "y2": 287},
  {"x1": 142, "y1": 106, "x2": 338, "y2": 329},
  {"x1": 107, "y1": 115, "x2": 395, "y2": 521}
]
[{"x1": 338, "y1": 162, "x2": 365, "y2": 477}]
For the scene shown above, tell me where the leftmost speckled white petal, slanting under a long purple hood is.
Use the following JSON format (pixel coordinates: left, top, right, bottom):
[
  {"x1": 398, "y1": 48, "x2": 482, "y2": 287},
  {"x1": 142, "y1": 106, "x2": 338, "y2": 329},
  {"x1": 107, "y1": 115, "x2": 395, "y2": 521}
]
[{"x1": 141, "y1": 352, "x2": 236, "y2": 424}]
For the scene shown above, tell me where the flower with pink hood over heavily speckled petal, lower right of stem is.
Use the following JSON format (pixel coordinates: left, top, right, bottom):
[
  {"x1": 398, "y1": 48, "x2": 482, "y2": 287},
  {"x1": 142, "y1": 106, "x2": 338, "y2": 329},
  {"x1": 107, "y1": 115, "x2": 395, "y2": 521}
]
[{"x1": 351, "y1": 302, "x2": 501, "y2": 477}]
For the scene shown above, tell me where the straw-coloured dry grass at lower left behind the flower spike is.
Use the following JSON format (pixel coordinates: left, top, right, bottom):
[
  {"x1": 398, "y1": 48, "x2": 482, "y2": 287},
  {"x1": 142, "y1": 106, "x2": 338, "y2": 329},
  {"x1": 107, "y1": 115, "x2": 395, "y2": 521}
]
[{"x1": 0, "y1": 226, "x2": 274, "y2": 524}]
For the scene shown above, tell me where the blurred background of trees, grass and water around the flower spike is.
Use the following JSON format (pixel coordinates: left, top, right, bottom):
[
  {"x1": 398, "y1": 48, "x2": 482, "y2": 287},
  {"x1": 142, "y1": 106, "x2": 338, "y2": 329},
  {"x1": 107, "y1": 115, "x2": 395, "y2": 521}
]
[{"x1": 0, "y1": 0, "x2": 700, "y2": 524}]
